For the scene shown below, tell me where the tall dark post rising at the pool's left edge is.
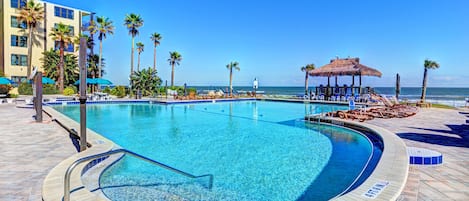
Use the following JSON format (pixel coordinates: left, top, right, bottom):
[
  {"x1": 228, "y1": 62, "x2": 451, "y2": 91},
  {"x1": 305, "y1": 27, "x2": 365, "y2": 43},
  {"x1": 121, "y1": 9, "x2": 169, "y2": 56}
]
[{"x1": 78, "y1": 37, "x2": 87, "y2": 152}]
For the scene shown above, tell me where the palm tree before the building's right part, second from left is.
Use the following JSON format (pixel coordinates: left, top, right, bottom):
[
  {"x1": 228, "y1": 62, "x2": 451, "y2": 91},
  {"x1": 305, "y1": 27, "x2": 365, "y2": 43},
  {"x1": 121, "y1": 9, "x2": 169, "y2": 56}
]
[{"x1": 49, "y1": 23, "x2": 72, "y2": 93}]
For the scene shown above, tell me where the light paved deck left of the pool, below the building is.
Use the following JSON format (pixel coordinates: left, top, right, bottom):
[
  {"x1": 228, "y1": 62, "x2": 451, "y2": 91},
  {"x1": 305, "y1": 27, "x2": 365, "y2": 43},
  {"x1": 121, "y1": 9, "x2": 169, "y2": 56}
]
[{"x1": 0, "y1": 104, "x2": 77, "y2": 201}]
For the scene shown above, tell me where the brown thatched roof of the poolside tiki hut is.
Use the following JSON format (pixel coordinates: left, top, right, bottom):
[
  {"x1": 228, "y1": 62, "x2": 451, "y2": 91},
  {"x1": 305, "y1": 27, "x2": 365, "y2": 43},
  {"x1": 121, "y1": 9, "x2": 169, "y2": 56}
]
[{"x1": 308, "y1": 58, "x2": 381, "y2": 77}]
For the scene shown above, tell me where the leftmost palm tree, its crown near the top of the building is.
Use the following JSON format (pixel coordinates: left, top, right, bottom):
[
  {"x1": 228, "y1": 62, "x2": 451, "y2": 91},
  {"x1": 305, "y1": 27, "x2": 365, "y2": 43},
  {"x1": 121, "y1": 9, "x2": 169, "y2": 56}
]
[{"x1": 19, "y1": 0, "x2": 44, "y2": 77}]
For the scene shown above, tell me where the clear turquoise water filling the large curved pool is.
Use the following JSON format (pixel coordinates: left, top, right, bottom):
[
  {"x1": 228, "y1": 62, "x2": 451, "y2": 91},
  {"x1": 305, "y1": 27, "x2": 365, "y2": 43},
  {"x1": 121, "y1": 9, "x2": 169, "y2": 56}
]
[{"x1": 54, "y1": 101, "x2": 372, "y2": 200}]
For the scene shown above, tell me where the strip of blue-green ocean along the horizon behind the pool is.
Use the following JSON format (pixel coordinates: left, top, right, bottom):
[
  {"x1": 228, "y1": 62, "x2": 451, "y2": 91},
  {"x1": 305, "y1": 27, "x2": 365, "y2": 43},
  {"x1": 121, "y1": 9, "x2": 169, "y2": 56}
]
[{"x1": 190, "y1": 86, "x2": 469, "y2": 107}]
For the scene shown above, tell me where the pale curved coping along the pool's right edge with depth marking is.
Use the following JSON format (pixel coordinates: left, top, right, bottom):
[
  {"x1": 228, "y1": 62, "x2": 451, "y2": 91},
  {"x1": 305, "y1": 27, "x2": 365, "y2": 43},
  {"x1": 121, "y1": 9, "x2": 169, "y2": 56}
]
[{"x1": 316, "y1": 118, "x2": 409, "y2": 201}]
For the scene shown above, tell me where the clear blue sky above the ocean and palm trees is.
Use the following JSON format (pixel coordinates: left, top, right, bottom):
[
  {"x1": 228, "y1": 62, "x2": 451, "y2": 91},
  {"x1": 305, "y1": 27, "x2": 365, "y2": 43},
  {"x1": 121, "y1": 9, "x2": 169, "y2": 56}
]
[{"x1": 44, "y1": 0, "x2": 469, "y2": 87}]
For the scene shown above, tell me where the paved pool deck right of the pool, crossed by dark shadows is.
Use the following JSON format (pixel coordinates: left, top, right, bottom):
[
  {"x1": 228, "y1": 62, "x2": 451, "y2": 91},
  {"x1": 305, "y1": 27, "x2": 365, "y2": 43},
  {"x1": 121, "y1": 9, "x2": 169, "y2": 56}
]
[{"x1": 367, "y1": 108, "x2": 469, "y2": 200}]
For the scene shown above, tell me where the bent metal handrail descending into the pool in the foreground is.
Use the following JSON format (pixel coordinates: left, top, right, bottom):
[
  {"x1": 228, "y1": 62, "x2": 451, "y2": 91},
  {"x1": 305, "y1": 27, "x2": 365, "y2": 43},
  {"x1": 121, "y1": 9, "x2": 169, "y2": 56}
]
[{"x1": 63, "y1": 149, "x2": 213, "y2": 201}]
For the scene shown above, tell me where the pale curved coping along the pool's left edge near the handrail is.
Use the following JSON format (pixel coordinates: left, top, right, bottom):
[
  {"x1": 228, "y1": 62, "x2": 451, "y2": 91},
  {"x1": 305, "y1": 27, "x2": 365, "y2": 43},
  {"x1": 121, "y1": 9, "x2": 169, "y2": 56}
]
[{"x1": 42, "y1": 107, "x2": 115, "y2": 201}]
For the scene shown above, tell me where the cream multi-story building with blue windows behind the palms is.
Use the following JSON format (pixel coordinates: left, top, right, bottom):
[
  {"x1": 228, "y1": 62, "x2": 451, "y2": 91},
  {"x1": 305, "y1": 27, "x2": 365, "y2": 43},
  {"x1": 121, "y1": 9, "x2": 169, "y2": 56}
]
[{"x1": 0, "y1": 0, "x2": 91, "y2": 83}]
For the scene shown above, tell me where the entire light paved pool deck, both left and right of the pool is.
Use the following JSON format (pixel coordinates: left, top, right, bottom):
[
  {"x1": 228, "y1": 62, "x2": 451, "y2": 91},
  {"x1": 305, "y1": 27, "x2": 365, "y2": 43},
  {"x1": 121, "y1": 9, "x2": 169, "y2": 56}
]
[{"x1": 0, "y1": 100, "x2": 469, "y2": 201}]
